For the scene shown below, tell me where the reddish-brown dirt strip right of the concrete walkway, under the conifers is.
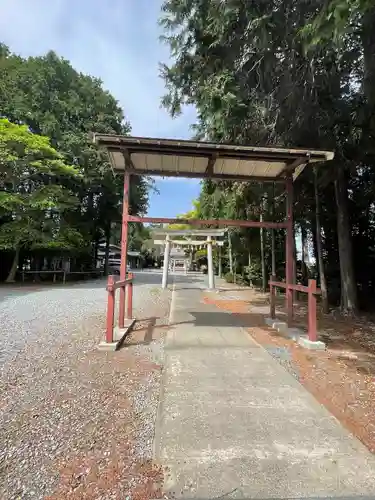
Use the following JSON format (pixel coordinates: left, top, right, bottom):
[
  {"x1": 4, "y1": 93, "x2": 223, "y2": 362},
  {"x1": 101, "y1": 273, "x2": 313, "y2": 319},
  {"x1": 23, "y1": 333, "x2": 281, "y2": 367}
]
[{"x1": 205, "y1": 286, "x2": 375, "y2": 453}]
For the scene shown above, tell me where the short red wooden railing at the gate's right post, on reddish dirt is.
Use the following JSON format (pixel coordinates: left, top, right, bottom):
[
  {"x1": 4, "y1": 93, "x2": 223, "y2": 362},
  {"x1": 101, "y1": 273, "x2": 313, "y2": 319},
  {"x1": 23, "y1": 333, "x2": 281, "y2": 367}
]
[{"x1": 269, "y1": 277, "x2": 321, "y2": 342}]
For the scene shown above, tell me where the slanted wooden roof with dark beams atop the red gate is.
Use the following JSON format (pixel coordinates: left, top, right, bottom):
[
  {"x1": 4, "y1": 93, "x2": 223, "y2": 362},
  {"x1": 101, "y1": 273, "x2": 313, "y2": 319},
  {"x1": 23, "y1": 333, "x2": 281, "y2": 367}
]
[{"x1": 93, "y1": 134, "x2": 334, "y2": 182}]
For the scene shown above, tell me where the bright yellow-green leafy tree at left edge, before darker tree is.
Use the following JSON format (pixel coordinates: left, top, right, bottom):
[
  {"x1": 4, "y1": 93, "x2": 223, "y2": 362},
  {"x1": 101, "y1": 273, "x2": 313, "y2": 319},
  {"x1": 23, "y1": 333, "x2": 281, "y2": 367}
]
[{"x1": 0, "y1": 118, "x2": 81, "y2": 249}]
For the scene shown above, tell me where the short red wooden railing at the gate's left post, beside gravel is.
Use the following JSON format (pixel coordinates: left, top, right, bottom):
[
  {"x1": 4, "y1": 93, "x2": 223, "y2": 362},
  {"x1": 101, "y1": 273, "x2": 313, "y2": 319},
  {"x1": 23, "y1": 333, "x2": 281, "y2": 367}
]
[{"x1": 105, "y1": 273, "x2": 133, "y2": 343}]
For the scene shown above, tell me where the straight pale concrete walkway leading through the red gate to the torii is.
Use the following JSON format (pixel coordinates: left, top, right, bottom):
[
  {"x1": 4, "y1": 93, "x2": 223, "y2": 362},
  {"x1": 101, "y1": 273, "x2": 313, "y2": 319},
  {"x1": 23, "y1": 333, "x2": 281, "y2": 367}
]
[{"x1": 155, "y1": 278, "x2": 375, "y2": 499}]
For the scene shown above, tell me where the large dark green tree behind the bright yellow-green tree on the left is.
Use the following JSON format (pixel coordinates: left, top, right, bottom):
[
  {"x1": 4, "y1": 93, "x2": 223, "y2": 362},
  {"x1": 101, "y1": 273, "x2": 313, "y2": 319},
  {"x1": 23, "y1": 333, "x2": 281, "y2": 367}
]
[{"x1": 0, "y1": 45, "x2": 150, "y2": 278}]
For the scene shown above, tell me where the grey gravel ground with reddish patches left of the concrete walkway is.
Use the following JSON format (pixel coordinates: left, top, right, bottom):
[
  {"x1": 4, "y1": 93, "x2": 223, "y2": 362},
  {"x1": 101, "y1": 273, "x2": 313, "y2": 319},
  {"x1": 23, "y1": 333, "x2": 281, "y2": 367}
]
[{"x1": 0, "y1": 274, "x2": 171, "y2": 500}]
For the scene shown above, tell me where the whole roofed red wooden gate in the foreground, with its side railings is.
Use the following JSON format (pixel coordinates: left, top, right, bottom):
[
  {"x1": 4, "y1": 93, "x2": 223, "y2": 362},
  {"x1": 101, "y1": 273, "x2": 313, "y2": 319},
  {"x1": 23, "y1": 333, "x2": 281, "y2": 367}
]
[{"x1": 93, "y1": 134, "x2": 334, "y2": 343}]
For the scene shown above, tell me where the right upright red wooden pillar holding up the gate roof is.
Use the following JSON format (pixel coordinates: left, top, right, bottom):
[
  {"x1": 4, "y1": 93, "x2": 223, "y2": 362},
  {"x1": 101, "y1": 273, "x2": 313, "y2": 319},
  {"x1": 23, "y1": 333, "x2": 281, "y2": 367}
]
[{"x1": 285, "y1": 175, "x2": 293, "y2": 326}]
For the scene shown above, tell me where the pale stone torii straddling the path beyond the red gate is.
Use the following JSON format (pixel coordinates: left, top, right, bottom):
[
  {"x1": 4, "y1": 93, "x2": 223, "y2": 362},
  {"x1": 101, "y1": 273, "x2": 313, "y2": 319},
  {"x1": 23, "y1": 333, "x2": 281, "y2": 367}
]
[{"x1": 153, "y1": 229, "x2": 226, "y2": 290}]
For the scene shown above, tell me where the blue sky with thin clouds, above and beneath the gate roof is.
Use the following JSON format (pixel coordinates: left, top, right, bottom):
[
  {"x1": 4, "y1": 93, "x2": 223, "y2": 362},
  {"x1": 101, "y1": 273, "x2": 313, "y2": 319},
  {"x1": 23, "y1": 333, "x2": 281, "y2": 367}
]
[{"x1": 0, "y1": 0, "x2": 199, "y2": 217}]
